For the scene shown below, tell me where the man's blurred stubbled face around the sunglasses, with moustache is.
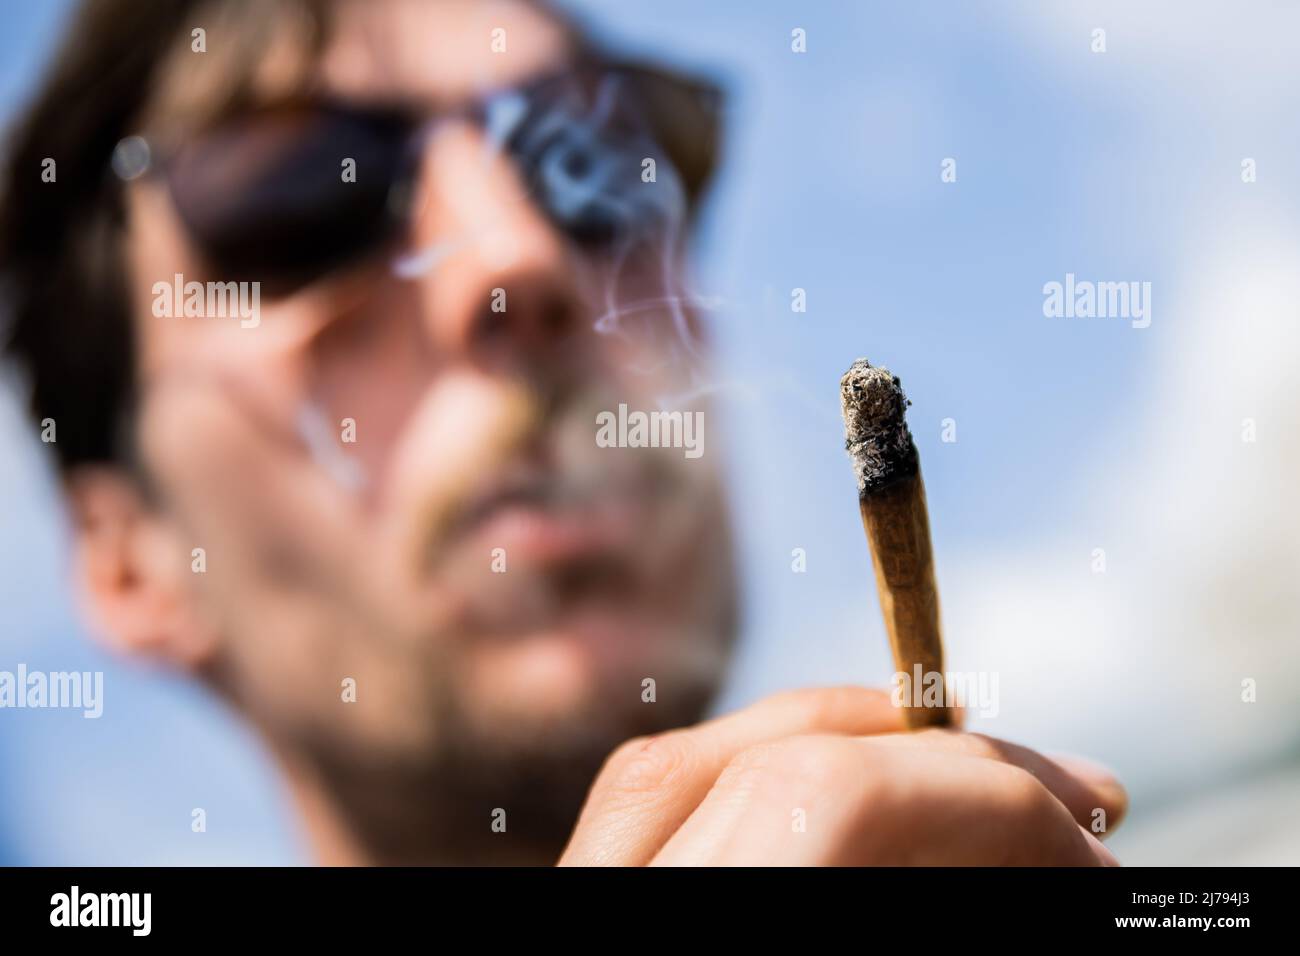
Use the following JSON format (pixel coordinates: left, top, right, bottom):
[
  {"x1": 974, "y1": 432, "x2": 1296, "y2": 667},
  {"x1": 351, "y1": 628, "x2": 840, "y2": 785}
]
[{"x1": 107, "y1": 0, "x2": 733, "y2": 806}]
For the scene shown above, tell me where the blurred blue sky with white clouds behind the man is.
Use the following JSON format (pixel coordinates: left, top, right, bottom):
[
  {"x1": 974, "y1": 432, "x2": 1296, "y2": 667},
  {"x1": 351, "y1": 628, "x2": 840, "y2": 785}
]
[{"x1": 0, "y1": 0, "x2": 1300, "y2": 862}]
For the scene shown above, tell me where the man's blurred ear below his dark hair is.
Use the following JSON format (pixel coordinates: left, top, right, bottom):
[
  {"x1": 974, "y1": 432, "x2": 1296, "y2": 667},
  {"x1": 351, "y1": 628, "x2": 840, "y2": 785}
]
[{"x1": 66, "y1": 466, "x2": 216, "y2": 670}]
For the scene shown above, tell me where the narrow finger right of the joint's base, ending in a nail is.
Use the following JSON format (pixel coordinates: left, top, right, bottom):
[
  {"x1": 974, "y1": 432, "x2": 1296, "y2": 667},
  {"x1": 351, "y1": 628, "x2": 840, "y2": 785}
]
[{"x1": 876, "y1": 730, "x2": 1128, "y2": 832}]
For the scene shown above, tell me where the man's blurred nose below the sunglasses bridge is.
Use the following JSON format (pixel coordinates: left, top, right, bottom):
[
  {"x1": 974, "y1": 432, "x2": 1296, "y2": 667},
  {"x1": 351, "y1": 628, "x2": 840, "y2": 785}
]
[{"x1": 411, "y1": 124, "x2": 580, "y2": 368}]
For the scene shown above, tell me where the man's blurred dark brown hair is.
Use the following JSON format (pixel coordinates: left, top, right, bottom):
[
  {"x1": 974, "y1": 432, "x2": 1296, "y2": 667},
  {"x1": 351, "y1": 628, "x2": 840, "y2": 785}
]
[{"x1": 0, "y1": 0, "x2": 720, "y2": 470}]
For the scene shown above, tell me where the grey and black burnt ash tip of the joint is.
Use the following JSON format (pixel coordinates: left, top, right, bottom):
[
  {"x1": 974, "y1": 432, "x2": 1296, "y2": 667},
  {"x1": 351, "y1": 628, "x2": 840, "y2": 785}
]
[{"x1": 840, "y1": 359, "x2": 918, "y2": 496}]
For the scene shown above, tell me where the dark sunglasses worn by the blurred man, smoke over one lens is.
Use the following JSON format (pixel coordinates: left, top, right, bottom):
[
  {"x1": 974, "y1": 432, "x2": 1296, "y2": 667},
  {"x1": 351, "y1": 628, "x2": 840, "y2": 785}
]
[{"x1": 112, "y1": 56, "x2": 720, "y2": 295}]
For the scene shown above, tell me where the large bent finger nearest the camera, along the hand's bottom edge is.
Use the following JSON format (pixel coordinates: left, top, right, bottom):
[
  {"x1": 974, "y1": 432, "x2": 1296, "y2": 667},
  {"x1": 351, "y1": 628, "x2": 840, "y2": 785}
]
[{"x1": 653, "y1": 736, "x2": 1102, "y2": 866}]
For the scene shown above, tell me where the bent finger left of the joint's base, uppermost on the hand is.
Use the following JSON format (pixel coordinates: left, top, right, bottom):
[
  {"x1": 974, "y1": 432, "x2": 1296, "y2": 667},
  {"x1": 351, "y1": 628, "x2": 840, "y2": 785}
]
[{"x1": 560, "y1": 687, "x2": 904, "y2": 866}]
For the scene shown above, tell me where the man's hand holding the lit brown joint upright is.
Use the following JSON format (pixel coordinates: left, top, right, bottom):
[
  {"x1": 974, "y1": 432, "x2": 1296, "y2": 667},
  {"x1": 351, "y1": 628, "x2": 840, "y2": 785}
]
[{"x1": 560, "y1": 687, "x2": 1127, "y2": 866}]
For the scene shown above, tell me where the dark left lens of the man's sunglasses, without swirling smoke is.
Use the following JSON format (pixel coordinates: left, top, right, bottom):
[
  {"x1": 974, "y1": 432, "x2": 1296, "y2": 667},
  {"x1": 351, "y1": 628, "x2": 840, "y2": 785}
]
[{"x1": 169, "y1": 109, "x2": 411, "y2": 294}]
